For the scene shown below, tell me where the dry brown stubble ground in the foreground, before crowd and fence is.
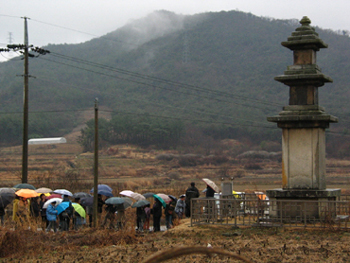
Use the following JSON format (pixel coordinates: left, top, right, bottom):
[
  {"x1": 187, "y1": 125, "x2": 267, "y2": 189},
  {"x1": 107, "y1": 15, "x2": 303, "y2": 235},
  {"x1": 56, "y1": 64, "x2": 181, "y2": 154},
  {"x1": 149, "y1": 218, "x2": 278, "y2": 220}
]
[{"x1": 0, "y1": 219, "x2": 350, "y2": 262}]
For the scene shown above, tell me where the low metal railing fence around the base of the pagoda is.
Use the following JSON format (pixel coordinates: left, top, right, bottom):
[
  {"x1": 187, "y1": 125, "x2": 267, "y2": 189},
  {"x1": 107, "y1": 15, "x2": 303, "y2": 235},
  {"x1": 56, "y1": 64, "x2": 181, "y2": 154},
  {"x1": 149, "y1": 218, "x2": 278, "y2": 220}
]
[{"x1": 191, "y1": 194, "x2": 350, "y2": 229}]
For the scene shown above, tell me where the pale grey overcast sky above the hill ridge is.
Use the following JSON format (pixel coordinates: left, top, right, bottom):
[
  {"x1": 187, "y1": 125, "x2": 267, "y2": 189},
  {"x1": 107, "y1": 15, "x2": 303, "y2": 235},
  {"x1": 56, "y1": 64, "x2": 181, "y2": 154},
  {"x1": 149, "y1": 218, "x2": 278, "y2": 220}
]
[{"x1": 0, "y1": 0, "x2": 350, "y2": 60}]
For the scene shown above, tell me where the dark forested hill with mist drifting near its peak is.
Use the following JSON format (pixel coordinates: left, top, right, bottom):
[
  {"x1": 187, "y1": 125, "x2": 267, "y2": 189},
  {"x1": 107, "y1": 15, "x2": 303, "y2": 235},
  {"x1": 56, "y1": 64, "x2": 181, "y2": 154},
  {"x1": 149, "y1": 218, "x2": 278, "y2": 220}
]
[{"x1": 0, "y1": 11, "x2": 350, "y2": 148}]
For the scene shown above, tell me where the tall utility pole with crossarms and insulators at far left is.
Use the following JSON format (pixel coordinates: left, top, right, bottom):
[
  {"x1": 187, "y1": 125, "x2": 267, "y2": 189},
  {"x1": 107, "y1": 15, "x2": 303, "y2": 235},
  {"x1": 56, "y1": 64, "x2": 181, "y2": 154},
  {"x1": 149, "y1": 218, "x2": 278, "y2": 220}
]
[{"x1": 0, "y1": 17, "x2": 50, "y2": 183}]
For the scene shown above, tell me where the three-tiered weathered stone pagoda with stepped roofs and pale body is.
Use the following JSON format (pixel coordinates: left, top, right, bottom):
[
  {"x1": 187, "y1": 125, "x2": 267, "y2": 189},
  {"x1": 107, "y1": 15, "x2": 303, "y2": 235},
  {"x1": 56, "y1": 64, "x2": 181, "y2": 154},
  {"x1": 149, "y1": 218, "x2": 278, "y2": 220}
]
[{"x1": 267, "y1": 17, "x2": 340, "y2": 217}]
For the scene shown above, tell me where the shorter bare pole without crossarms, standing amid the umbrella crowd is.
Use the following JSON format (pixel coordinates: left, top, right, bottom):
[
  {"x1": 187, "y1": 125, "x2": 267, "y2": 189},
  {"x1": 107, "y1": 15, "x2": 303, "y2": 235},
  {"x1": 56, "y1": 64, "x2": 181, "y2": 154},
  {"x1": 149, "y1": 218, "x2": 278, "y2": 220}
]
[{"x1": 93, "y1": 98, "x2": 98, "y2": 228}]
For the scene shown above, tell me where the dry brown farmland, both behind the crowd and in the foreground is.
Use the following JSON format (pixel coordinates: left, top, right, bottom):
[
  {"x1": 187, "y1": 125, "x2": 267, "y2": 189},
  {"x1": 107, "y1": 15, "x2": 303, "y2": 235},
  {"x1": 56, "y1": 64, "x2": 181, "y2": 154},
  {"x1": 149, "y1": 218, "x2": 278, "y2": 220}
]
[{"x1": 0, "y1": 144, "x2": 350, "y2": 263}]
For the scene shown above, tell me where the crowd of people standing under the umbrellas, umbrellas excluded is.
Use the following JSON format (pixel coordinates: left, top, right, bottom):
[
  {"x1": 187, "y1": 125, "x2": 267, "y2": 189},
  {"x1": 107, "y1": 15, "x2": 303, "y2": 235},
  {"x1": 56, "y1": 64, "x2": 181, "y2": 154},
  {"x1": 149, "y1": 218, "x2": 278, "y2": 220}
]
[{"x1": 0, "y1": 182, "x2": 211, "y2": 232}]
